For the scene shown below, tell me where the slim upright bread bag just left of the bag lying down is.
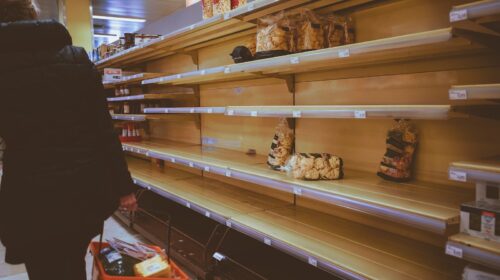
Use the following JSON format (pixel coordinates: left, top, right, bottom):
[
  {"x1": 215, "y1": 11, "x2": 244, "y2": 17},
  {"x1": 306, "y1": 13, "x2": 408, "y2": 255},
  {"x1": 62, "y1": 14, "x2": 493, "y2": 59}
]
[{"x1": 267, "y1": 119, "x2": 294, "y2": 171}]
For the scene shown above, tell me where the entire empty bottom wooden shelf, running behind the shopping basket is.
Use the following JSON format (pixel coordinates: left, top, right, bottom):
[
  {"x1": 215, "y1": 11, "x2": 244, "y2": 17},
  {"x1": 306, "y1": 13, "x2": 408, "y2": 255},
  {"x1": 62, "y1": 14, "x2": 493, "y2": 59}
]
[{"x1": 129, "y1": 156, "x2": 464, "y2": 279}]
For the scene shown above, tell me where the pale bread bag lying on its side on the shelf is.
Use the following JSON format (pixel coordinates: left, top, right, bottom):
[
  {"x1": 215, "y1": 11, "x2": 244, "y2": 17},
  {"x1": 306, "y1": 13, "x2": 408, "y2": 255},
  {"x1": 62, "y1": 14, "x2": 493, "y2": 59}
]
[{"x1": 285, "y1": 153, "x2": 344, "y2": 180}]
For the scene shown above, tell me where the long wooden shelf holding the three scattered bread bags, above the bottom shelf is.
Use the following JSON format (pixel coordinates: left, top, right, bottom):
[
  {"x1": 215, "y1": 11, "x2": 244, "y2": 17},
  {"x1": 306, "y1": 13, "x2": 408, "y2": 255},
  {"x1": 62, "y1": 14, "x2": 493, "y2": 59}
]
[{"x1": 123, "y1": 141, "x2": 473, "y2": 234}]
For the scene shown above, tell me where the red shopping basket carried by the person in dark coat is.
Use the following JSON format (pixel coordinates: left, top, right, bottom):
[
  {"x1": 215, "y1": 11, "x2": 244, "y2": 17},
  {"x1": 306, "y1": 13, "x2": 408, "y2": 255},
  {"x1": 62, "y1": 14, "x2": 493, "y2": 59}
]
[{"x1": 90, "y1": 242, "x2": 189, "y2": 280}]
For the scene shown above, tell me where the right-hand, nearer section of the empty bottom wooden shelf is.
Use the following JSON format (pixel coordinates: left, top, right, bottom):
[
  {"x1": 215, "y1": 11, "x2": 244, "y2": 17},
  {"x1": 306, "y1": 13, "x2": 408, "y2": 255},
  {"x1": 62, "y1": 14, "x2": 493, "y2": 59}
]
[{"x1": 231, "y1": 206, "x2": 463, "y2": 279}]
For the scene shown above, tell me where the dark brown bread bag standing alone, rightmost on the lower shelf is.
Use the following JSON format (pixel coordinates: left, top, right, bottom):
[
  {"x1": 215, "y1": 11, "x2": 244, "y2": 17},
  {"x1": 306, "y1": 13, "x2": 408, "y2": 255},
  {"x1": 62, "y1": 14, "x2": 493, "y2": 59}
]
[{"x1": 377, "y1": 120, "x2": 418, "y2": 182}]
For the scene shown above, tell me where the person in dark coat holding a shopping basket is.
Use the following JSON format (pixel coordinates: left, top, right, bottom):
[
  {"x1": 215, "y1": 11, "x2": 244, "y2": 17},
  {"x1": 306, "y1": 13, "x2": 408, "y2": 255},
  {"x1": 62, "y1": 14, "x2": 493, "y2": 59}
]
[{"x1": 0, "y1": 0, "x2": 137, "y2": 280}]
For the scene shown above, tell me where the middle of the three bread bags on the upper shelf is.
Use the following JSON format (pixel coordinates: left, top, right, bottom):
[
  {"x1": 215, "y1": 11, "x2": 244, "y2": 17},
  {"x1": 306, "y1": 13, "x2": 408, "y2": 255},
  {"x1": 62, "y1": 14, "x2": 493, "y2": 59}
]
[{"x1": 295, "y1": 9, "x2": 325, "y2": 52}]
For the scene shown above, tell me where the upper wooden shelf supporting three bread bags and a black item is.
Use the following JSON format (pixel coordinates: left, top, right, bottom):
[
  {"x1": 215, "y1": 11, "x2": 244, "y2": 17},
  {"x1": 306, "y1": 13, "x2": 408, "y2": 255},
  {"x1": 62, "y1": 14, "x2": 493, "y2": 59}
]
[{"x1": 142, "y1": 28, "x2": 484, "y2": 91}]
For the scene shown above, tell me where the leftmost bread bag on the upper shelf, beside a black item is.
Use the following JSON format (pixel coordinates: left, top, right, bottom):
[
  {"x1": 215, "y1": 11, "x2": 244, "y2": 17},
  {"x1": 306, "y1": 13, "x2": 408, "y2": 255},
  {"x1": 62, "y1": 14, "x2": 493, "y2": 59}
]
[{"x1": 256, "y1": 12, "x2": 291, "y2": 59}]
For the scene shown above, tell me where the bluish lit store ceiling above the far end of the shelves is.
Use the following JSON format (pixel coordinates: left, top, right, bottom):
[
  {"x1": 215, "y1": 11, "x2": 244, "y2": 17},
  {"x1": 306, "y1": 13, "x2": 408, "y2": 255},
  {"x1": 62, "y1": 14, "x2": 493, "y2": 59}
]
[{"x1": 92, "y1": 0, "x2": 186, "y2": 36}]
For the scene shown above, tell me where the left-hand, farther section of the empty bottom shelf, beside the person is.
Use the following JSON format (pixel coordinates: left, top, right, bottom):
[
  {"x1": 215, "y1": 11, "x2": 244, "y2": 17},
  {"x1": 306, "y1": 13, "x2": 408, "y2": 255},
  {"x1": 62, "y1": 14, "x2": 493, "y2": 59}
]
[{"x1": 128, "y1": 158, "x2": 289, "y2": 224}]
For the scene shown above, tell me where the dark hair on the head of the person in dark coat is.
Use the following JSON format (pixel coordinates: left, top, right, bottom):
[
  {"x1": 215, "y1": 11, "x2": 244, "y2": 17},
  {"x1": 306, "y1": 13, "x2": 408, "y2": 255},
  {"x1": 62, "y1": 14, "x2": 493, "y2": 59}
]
[{"x1": 0, "y1": 0, "x2": 39, "y2": 22}]
